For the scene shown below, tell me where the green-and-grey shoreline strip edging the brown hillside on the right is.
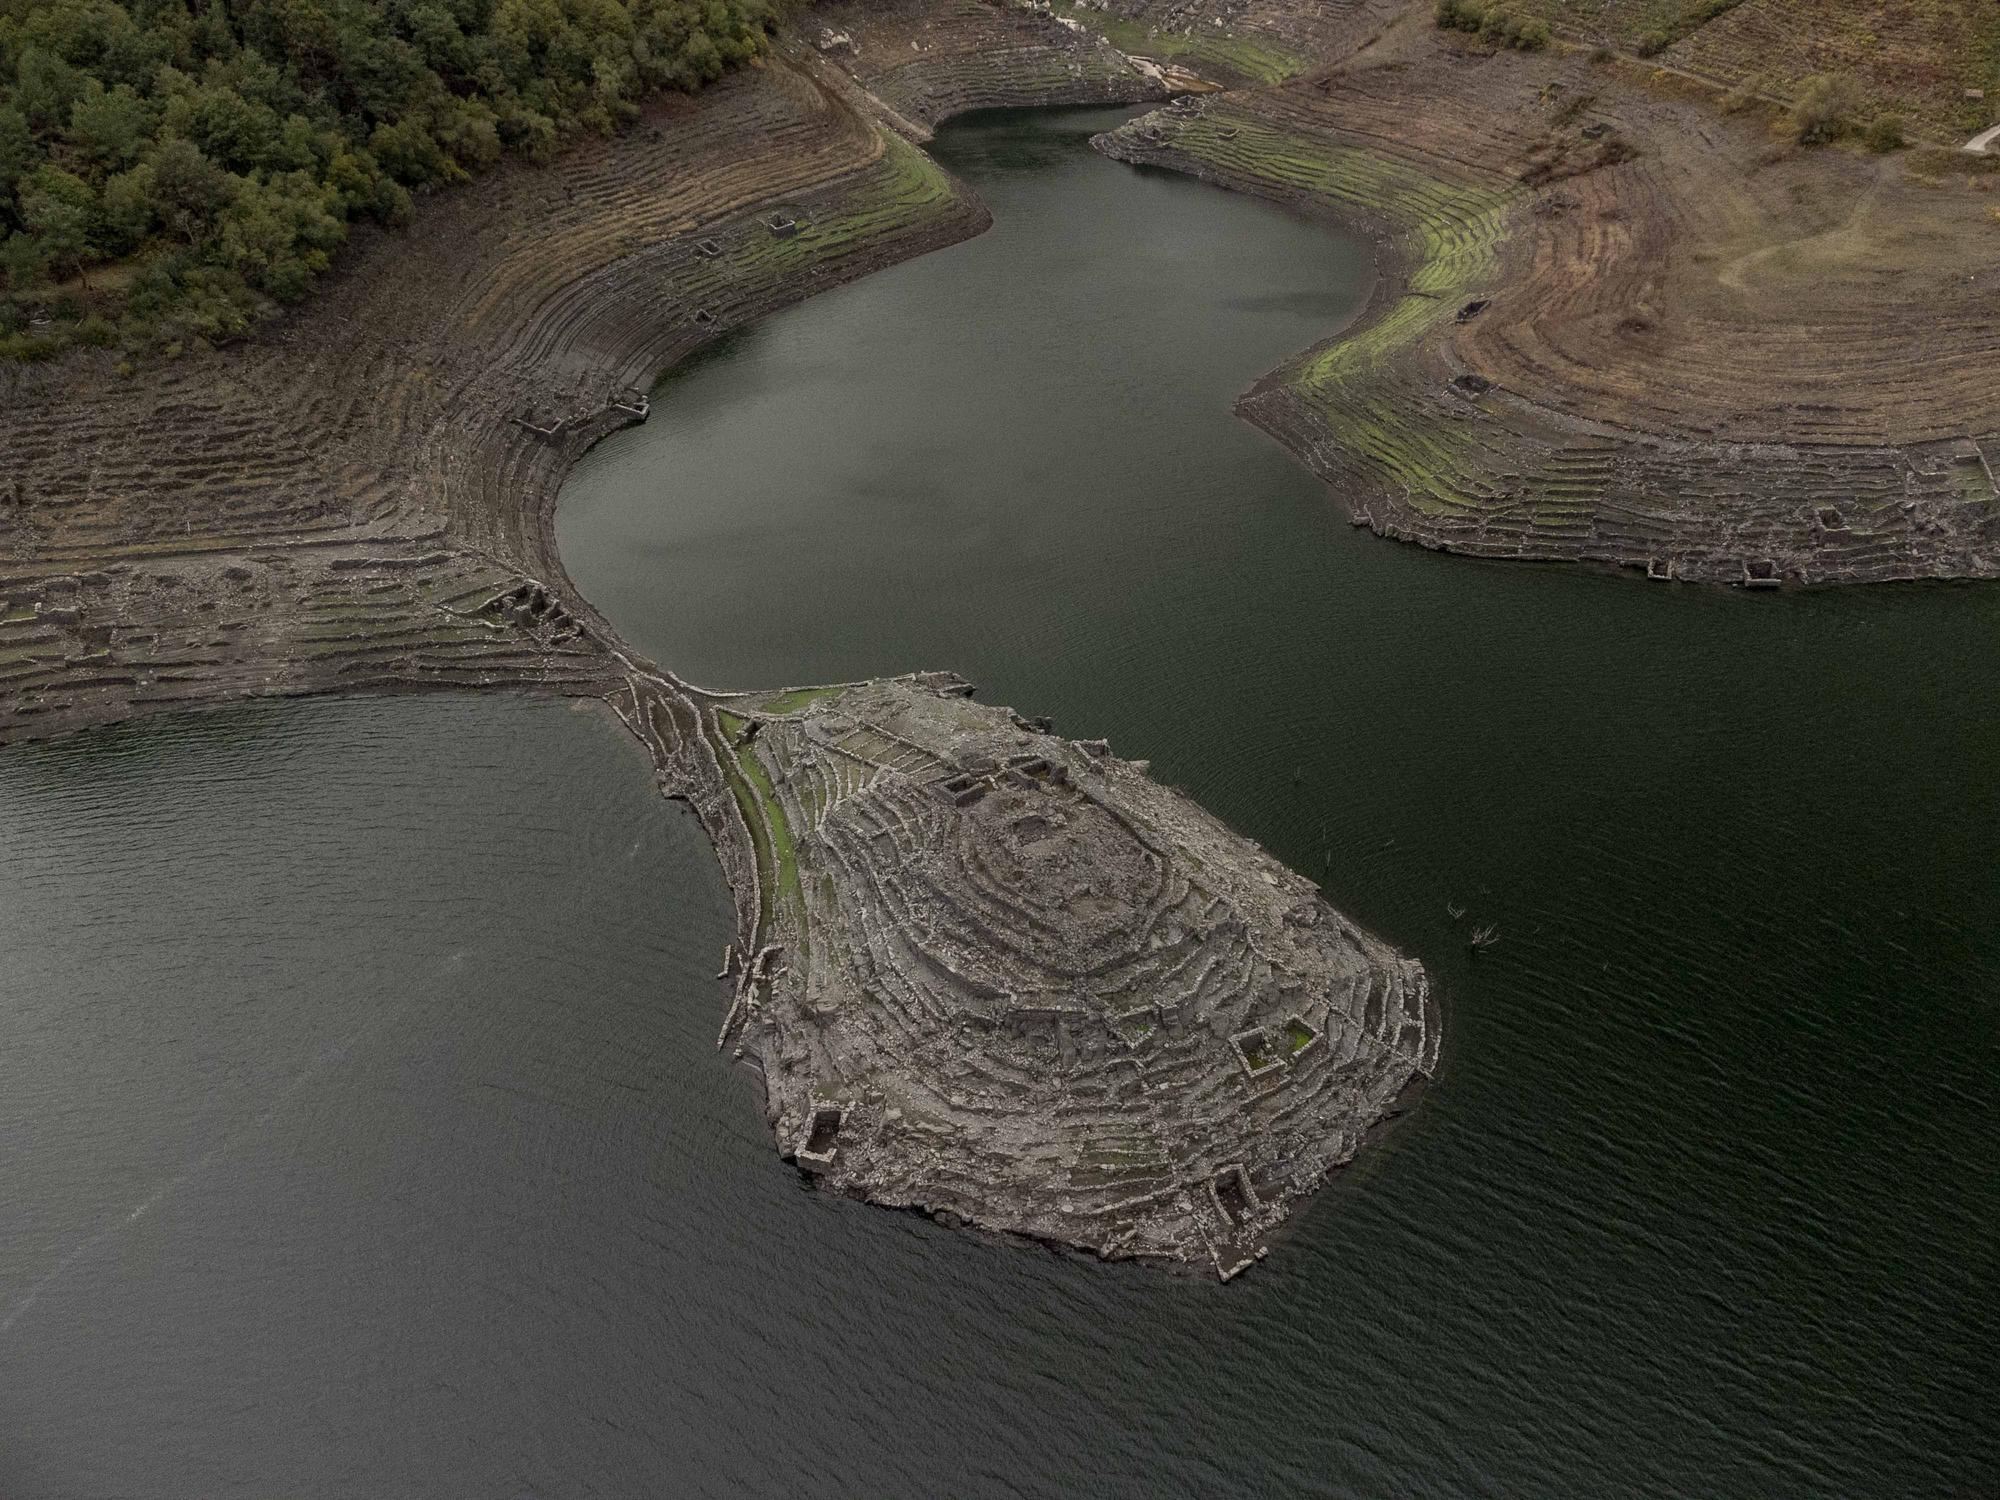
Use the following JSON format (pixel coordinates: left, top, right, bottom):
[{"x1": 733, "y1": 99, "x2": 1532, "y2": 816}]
[{"x1": 1096, "y1": 82, "x2": 2000, "y2": 588}]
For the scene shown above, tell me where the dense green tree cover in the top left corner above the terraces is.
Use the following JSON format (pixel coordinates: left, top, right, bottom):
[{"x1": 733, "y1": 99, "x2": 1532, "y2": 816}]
[{"x1": 0, "y1": 0, "x2": 766, "y2": 358}]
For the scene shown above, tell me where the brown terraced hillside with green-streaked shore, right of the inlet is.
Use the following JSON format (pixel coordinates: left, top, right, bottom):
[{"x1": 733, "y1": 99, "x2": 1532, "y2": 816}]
[{"x1": 1102, "y1": 16, "x2": 2000, "y2": 584}]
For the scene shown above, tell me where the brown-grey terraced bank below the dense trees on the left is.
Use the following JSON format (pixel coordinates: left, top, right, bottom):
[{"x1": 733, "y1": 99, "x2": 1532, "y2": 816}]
[{"x1": 0, "y1": 66, "x2": 984, "y2": 740}]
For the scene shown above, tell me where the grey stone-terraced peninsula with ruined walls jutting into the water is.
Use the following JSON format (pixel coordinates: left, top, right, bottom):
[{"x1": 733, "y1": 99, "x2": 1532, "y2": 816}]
[{"x1": 704, "y1": 674, "x2": 1438, "y2": 1278}]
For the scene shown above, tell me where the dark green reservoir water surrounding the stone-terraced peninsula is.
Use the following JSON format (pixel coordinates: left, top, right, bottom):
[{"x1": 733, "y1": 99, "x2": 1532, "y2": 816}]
[{"x1": 11, "y1": 114, "x2": 2000, "y2": 1500}]
